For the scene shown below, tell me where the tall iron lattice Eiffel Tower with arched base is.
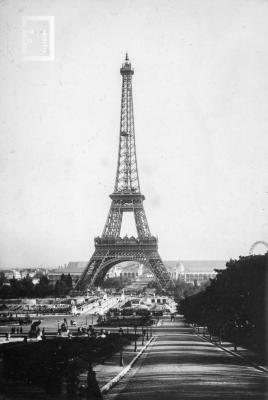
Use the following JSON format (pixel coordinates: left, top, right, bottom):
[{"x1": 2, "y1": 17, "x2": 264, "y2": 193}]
[{"x1": 75, "y1": 54, "x2": 174, "y2": 291}]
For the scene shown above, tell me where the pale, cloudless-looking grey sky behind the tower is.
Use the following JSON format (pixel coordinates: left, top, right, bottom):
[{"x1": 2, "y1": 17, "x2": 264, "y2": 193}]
[{"x1": 0, "y1": 0, "x2": 268, "y2": 267}]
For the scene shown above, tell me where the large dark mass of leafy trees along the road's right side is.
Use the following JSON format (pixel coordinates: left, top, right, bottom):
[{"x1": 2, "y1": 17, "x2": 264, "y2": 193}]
[{"x1": 179, "y1": 253, "x2": 268, "y2": 355}]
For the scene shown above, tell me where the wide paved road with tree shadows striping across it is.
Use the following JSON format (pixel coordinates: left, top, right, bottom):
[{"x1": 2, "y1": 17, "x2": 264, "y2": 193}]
[{"x1": 105, "y1": 318, "x2": 268, "y2": 400}]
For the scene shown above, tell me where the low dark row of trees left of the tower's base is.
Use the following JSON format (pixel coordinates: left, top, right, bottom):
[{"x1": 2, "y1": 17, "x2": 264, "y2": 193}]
[{"x1": 0, "y1": 274, "x2": 73, "y2": 299}]
